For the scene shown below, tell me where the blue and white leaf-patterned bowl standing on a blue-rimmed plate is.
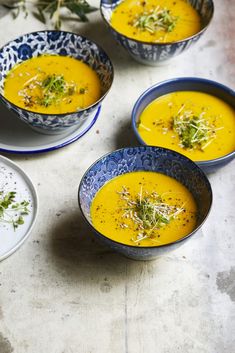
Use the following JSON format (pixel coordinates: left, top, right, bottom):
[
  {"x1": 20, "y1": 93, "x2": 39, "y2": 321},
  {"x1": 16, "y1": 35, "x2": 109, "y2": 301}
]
[{"x1": 0, "y1": 31, "x2": 114, "y2": 134}]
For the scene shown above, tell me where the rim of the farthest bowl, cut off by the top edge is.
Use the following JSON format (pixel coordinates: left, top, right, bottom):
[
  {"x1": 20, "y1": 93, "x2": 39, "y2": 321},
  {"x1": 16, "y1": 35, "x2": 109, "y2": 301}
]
[{"x1": 100, "y1": 0, "x2": 215, "y2": 46}]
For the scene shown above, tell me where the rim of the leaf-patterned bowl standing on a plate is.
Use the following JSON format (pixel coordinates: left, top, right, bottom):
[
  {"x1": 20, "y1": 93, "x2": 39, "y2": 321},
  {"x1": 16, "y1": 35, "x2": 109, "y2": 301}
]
[{"x1": 0, "y1": 29, "x2": 114, "y2": 117}]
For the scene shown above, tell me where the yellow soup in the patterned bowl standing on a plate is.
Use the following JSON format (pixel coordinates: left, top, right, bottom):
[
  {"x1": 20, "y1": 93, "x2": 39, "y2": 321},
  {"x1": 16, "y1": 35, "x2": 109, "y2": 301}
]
[{"x1": 4, "y1": 55, "x2": 101, "y2": 114}]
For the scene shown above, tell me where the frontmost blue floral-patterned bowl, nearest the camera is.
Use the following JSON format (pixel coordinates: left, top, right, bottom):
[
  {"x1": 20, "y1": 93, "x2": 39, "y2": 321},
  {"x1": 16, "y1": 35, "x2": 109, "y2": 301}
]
[{"x1": 78, "y1": 146, "x2": 212, "y2": 260}]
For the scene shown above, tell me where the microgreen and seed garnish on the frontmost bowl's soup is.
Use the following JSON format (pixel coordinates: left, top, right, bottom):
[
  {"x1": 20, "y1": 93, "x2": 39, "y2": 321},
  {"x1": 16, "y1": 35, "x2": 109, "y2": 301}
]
[{"x1": 118, "y1": 186, "x2": 184, "y2": 243}]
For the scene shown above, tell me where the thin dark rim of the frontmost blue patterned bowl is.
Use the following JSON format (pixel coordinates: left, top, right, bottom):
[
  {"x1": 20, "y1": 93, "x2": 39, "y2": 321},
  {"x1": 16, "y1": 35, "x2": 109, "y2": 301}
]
[{"x1": 78, "y1": 145, "x2": 213, "y2": 250}]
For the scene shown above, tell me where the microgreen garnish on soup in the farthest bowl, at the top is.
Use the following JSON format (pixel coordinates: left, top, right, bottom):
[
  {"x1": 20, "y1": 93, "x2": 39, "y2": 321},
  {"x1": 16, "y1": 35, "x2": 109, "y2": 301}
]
[{"x1": 133, "y1": 6, "x2": 178, "y2": 33}]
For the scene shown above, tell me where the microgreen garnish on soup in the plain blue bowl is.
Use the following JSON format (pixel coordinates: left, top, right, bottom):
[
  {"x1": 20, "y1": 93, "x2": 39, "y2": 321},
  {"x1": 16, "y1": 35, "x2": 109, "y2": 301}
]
[{"x1": 172, "y1": 105, "x2": 223, "y2": 150}]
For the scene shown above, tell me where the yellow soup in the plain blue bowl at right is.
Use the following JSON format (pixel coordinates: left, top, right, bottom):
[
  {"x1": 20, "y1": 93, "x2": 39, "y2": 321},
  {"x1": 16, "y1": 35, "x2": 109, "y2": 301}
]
[{"x1": 138, "y1": 91, "x2": 235, "y2": 161}]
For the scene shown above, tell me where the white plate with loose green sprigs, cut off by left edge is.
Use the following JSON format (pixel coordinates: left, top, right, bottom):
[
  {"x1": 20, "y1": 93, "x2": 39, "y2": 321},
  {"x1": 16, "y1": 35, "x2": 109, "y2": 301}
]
[{"x1": 0, "y1": 156, "x2": 38, "y2": 261}]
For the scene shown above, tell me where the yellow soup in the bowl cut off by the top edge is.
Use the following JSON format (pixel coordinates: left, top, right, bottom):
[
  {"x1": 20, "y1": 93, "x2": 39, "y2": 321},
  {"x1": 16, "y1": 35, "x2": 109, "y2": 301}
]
[{"x1": 111, "y1": 0, "x2": 202, "y2": 43}]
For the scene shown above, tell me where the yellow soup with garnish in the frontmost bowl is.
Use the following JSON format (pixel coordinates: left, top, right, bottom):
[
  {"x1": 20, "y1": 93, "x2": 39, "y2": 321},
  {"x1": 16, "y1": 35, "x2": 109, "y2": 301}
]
[{"x1": 91, "y1": 172, "x2": 197, "y2": 246}]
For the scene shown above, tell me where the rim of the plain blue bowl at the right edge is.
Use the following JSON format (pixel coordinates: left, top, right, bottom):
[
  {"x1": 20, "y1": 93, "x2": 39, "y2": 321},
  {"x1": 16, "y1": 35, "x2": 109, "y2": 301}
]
[{"x1": 131, "y1": 77, "x2": 235, "y2": 167}]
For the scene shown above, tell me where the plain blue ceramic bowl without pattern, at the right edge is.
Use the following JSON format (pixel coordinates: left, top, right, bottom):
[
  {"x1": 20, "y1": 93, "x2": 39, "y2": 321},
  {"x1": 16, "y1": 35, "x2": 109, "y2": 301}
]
[{"x1": 132, "y1": 77, "x2": 235, "y2": 173}]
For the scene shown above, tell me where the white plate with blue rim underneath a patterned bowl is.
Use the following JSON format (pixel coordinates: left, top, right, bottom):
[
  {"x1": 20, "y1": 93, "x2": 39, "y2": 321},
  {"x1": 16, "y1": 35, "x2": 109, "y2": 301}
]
[{"x1": 0, "y1": 103, "x2": 101, "y2": 153}]
